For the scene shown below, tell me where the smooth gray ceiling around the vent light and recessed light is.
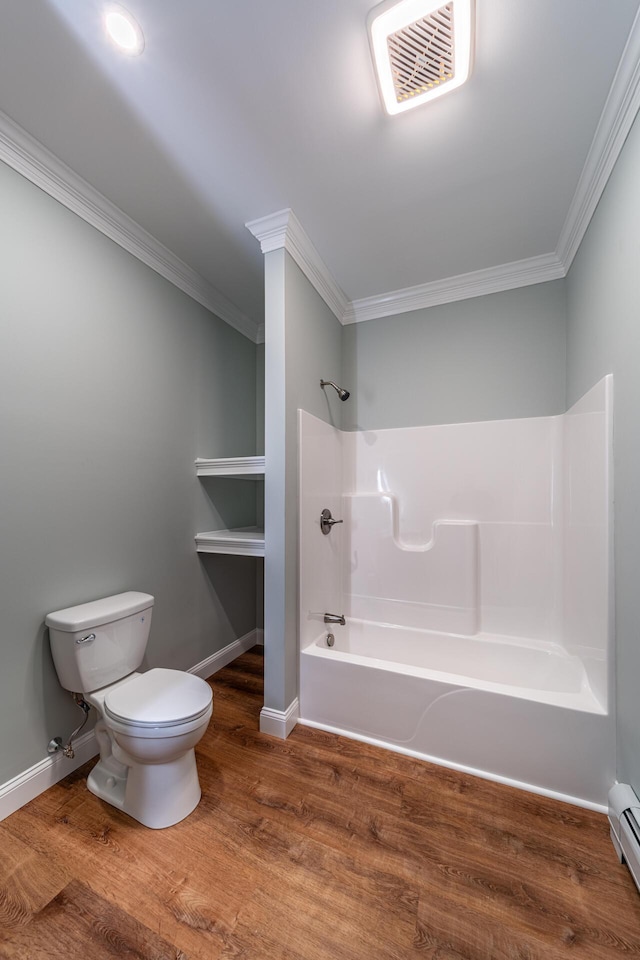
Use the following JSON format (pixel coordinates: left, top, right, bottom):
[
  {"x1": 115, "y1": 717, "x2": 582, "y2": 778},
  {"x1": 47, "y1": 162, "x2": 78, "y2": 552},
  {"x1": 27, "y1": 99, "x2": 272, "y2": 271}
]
[{"x1": 0, "y1": 0, "x2": 640, "y2": 338}]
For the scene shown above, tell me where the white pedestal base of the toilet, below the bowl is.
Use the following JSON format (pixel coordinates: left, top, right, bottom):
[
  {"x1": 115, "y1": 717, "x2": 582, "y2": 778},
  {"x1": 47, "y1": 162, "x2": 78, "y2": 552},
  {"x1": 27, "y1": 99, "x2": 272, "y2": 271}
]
[{"x1": 87, "y1": 749, "x2": 202, "y2": 830}]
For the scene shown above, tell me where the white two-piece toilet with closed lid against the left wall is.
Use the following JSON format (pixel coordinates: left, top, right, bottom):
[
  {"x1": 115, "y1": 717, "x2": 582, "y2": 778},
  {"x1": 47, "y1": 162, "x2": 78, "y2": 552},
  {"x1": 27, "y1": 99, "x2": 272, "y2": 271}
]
[{"x1": 45, "y1": 591, "x2": 213, "y2": 829}]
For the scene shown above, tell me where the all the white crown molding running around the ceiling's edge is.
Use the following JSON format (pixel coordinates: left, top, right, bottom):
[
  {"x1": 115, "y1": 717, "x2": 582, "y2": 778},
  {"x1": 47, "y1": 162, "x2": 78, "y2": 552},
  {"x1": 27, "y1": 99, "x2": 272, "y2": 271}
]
[{"x1": 6, "y1": 2, "x2": 640, "y2": 343}]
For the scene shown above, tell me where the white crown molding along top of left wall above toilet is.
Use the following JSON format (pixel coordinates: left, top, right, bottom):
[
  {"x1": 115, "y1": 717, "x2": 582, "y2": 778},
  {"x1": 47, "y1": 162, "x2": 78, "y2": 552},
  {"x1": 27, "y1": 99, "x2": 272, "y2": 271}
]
[{"x1": 0, "y1": 112, "x2": 259, "y2": 343}]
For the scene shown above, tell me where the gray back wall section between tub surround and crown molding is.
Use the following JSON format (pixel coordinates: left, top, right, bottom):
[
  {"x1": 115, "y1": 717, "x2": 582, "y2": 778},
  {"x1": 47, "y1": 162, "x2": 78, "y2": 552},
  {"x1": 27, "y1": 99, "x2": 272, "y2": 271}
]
[{"x1": 342, "y1": 280, "x2": 566, "y2": 430}]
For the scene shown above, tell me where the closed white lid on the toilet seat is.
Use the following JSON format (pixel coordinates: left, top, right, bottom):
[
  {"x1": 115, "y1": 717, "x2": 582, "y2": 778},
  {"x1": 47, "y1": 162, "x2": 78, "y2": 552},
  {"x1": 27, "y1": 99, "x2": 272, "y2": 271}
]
[{"x1": 104, "y1": 667, "x2": 213, "y2": 727}]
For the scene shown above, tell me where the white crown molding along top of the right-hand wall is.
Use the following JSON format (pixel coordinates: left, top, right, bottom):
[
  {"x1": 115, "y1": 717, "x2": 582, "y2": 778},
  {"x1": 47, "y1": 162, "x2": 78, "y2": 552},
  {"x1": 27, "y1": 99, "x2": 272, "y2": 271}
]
[{"x1": 557, "y1": 12, "x2": 640, "y2": 272}]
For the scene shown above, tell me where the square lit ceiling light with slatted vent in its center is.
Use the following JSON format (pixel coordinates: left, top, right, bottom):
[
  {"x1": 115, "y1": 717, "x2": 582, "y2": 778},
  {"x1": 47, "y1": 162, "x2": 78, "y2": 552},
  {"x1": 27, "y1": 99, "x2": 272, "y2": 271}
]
[{"x1": 368, "y1": 0, "x2": 475, "y2": 114}]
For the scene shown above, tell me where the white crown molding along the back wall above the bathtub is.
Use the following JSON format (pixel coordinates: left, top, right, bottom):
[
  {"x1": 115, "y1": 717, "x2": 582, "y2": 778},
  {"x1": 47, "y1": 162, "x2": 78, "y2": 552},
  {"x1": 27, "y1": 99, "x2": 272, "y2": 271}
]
[{"x1": 342, "y1": 254, "x2": 565, "y2": 324}]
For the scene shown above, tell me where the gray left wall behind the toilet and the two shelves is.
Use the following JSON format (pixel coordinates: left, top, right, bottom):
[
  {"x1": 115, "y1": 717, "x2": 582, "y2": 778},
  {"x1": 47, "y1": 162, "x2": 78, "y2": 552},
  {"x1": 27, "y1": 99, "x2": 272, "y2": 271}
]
[{"x1": 0, "y1": 159, "x2": 256, "y2": 783}]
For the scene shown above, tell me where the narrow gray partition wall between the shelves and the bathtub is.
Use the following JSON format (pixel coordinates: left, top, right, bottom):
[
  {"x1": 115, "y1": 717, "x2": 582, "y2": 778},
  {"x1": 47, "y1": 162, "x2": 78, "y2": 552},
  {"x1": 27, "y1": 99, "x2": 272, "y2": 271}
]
[{"x1": 264, "y1": 250, "x2": 345, "y2": 710}]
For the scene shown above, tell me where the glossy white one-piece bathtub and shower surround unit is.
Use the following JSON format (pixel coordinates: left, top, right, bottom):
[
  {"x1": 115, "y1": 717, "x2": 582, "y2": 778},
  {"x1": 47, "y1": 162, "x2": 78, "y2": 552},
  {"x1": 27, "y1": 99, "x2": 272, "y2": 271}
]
[{"x1": 300, "y1": 377, "x2": 615, "y2": 809}]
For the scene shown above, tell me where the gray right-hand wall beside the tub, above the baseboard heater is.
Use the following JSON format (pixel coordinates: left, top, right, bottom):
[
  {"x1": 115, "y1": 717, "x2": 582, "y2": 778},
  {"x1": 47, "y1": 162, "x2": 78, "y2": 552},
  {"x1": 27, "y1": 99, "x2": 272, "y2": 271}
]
[{"x1": 567, "y1": 107, "x2": 640, "y2": 794}]
